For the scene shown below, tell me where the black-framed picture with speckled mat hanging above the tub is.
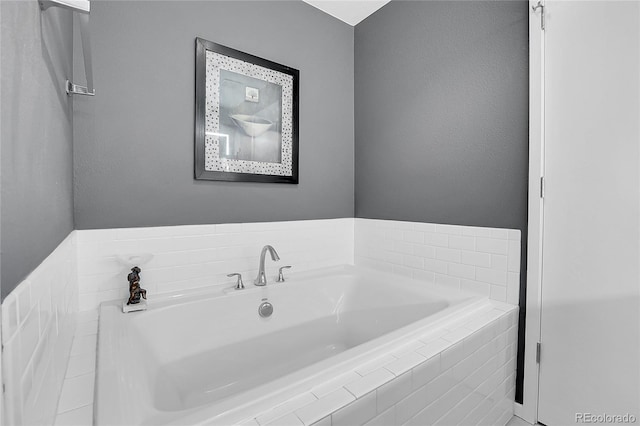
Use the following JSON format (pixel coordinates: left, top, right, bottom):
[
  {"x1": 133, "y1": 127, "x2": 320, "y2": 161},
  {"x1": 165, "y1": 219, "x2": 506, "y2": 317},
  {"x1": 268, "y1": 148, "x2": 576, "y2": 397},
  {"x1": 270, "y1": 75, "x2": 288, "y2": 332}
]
[{"x1": 195, "y1": 38, "x2": 299, "y2": 184}]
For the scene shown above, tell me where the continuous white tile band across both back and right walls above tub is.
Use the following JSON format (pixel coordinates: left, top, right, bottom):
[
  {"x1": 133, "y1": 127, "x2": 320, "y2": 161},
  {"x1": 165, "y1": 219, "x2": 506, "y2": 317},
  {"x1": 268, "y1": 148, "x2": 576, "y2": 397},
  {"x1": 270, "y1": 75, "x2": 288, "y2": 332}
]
[{"x1": 77, "y1": 219, "x2": 520, "y2": 310}]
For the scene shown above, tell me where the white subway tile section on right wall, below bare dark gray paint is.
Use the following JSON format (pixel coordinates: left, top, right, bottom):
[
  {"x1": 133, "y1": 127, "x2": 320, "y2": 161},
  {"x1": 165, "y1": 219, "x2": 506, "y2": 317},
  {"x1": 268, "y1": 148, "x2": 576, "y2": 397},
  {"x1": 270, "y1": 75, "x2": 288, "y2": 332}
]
[{"x1": 354, "y1": 219, "x2": 520, "y2": 305}]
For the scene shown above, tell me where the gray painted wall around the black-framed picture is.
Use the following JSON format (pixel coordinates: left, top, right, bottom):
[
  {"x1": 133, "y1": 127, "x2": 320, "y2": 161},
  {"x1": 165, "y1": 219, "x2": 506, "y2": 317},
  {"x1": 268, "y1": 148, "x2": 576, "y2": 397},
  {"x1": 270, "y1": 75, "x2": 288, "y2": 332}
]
[{"x1": 74, "y1": 1, "x2": 354, "y2": 229}]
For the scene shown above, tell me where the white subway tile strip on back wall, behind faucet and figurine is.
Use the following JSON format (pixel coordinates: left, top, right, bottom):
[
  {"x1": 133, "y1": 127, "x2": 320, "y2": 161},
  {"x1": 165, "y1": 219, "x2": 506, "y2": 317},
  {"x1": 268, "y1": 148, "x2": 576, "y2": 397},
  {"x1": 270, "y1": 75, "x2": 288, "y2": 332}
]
[{"x1": 77, "y1": 218, "x2": 353, "y2": 310}]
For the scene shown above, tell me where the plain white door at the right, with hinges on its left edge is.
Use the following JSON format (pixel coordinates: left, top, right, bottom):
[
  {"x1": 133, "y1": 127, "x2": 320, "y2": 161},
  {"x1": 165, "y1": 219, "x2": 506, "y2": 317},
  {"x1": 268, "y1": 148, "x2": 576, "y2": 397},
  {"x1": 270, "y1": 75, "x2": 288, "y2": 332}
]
[{"x1": 532, "y1": 1, "x2": 640, "y2": 426}]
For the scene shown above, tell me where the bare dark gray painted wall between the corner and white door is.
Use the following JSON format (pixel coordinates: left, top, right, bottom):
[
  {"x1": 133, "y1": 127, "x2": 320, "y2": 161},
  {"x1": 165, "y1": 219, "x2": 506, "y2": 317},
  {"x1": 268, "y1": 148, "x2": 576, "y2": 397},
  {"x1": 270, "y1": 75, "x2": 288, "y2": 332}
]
[{"x1": 355, "y1": 1, "x2": 528, "y2": 231}]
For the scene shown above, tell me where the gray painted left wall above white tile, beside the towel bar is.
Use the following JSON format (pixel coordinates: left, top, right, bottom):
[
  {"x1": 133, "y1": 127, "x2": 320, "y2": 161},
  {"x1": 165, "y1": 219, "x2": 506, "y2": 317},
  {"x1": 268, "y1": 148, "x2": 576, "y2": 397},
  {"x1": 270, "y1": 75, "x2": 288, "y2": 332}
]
[{"x1": 0, "y1": 1, "x2": 73, "y2": 298}]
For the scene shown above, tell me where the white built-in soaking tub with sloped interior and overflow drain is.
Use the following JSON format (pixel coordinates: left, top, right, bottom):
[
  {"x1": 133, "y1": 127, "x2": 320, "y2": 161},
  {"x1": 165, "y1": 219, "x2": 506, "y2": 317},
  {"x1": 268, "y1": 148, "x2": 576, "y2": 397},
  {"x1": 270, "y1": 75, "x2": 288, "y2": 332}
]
[{"x1": 95, "y1": 266, "x2": 484, "y2": 425}]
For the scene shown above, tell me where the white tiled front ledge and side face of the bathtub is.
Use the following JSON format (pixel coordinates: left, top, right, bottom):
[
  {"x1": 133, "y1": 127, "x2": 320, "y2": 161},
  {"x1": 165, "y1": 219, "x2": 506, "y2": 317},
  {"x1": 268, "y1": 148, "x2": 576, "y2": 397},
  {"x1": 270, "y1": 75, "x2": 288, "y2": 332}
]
[{"x1": 243, "y1": 304, "x2": 517, "y2": 426}]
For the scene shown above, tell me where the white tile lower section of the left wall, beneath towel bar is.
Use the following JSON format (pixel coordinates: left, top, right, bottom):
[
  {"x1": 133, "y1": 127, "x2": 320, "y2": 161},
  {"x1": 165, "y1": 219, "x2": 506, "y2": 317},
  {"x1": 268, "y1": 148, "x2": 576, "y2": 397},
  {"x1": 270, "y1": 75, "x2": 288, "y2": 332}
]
[{"x1": 2, "y1": 232, "x2": 77, "y2": 425}]
